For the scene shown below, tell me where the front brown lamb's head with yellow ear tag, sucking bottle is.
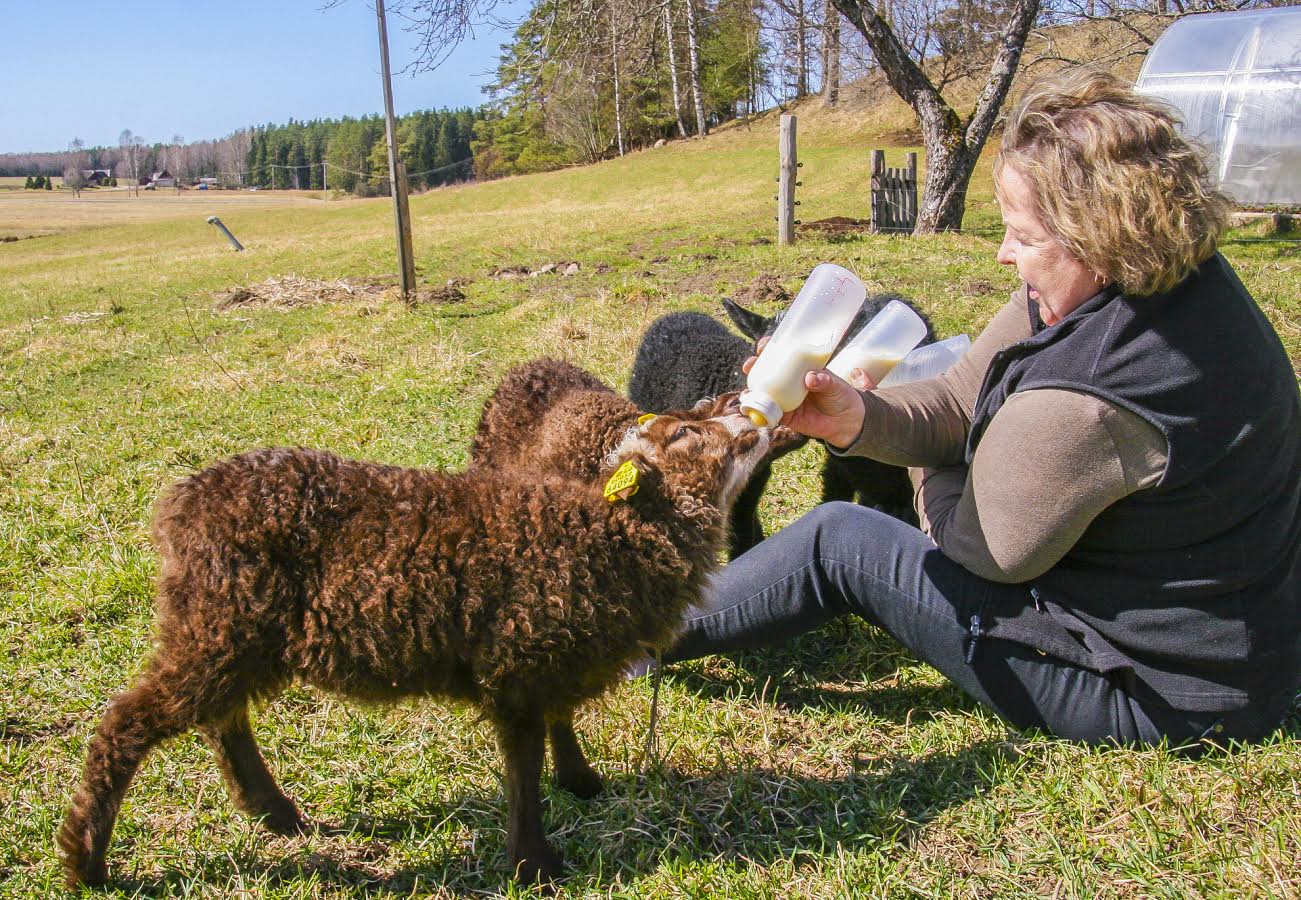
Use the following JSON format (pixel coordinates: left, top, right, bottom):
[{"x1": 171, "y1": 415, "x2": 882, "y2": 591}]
[{"x1": 602, "y1": 404, "x2": 771, "y2": 523}]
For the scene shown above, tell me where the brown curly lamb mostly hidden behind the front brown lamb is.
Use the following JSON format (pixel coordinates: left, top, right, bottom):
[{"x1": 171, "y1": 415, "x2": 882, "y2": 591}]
[{"x1": 470, "y1": 359, "x2": 804, "y2": 481}]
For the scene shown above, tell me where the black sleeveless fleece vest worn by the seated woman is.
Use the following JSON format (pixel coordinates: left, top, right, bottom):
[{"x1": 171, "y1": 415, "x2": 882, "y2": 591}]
[{"x1": 967, "y1": 254, "x2": 1301, "y2": 710}]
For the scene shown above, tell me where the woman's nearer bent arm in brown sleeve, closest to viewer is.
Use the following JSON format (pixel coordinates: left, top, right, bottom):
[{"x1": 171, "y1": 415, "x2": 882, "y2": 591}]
[{"x1": 909, "y1": 389, "x2": 1166, "y2": 583}]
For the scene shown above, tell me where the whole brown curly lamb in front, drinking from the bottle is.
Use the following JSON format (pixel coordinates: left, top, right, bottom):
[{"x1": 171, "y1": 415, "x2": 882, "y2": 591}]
[{"x1": 59, "y1": 415, "x2": 769, "y2": 884}]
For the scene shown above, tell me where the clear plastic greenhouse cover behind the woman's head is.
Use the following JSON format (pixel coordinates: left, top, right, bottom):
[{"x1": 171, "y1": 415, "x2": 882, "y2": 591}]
[{"x1": 1134, "y1": 7, "x2": 1301, "y2": 205}]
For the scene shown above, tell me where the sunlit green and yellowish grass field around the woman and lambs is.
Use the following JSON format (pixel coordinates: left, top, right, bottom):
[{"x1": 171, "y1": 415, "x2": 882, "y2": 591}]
[{"x1": 0, "y1": 100, "x2": 1301, "y2": 897}]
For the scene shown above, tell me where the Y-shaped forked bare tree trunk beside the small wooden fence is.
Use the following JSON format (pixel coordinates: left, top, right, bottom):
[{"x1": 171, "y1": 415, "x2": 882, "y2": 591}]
[{"x1": 831, "y1": 0, "x2": 1039, "y2": 234}]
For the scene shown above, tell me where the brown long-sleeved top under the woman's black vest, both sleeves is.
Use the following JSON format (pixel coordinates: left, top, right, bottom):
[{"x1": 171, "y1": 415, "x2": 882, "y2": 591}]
[{"x1": 833, "y1": 287, "x2": 1167, "y2": 583}]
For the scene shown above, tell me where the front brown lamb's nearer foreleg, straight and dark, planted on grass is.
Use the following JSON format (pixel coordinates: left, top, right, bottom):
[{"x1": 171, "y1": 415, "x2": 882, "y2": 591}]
[{"x1": 497, "y1": 713, "x2": 563, "y2": 882}]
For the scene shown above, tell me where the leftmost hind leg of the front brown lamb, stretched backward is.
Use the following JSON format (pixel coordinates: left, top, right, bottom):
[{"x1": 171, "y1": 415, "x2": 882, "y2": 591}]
[{"x1": 57, "y1": 668, "x2": 194, "y2": 887}]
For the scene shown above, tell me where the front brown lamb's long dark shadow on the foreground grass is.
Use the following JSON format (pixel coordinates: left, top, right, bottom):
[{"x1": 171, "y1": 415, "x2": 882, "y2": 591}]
[{"x1": 112, "y1": 741, "x2": 1016, "y2": 897}]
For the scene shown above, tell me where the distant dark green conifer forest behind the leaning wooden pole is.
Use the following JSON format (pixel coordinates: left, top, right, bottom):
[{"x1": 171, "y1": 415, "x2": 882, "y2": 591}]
[{"x1": 242, "y1": 108, "x2": 483, "y2": 195}]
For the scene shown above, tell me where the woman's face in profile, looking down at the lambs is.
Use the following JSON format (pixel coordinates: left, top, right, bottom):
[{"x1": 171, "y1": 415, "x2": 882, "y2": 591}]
[{"x1": 998, "y1": 165, "x2": 1101, "y2": 325}]
